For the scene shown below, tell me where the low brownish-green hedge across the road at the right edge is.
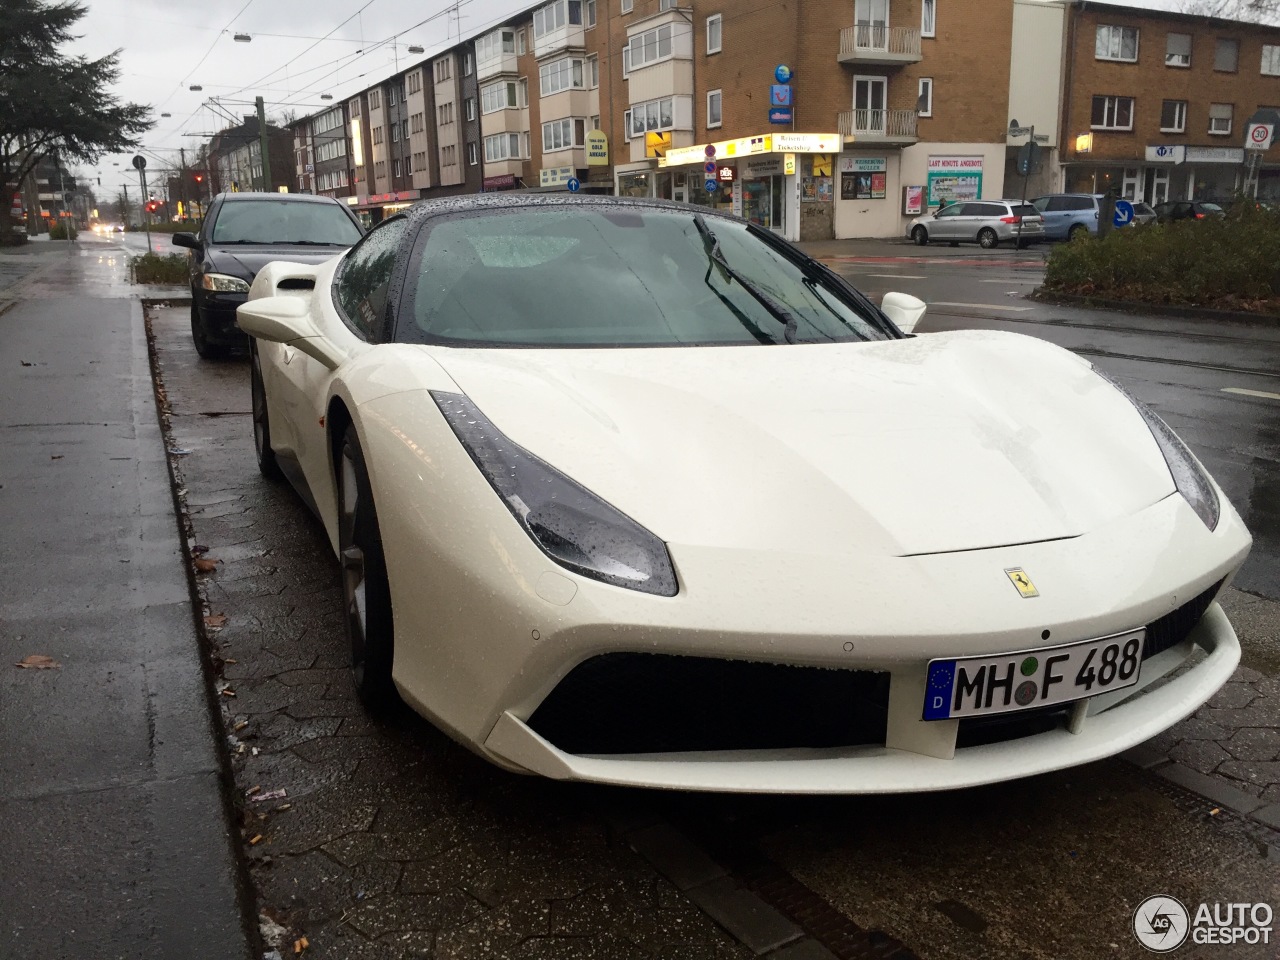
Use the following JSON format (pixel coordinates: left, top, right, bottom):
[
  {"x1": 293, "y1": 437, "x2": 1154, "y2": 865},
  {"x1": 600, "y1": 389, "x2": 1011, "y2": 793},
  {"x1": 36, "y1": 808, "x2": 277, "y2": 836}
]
[{"x1": 1044, "y1": 201, "x2": 1280, "y2": 314}]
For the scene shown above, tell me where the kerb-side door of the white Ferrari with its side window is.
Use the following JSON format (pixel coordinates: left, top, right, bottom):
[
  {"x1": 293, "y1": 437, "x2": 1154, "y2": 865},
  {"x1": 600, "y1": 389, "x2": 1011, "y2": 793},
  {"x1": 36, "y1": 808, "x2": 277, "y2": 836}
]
[{"x1": 269, "y1": 216, "x2": 408, "y2": 499}]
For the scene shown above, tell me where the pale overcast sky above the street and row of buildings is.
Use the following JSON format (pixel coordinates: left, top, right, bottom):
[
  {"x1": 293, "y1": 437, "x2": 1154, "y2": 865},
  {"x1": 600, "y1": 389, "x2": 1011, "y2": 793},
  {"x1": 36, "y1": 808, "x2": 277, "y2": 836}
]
[{"x1": 72, "y1": 0, "x2": 1179, "y2": 201}]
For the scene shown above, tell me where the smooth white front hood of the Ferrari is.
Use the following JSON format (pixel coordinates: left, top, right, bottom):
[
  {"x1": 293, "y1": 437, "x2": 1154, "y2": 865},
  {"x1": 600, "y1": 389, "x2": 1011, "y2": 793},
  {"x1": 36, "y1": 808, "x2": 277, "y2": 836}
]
[{"x1": 422, "y1": 332, "x2": 1174, "y2": 559}]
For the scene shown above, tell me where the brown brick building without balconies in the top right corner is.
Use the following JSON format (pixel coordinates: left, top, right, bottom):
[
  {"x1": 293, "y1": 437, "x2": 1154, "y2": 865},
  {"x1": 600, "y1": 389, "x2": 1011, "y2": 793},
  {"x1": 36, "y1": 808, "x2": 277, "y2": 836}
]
[{"x1": 1062, "y1": 0, "x2": 1280, "y2": 204}]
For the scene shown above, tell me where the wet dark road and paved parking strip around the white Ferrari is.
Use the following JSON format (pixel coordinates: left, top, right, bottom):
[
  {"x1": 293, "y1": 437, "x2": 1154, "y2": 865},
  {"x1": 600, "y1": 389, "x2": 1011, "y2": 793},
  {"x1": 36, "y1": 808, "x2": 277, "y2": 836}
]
[{"x1": 140, "y1": 235, "x2": 1280, "y2": 960}]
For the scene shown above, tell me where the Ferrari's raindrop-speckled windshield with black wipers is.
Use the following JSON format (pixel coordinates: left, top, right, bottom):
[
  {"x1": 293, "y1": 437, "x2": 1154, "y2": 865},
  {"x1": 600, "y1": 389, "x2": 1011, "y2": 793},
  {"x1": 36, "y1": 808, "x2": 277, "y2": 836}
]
[{"x1": 399, "y1": 205, "x2": 891, "y2": 347}]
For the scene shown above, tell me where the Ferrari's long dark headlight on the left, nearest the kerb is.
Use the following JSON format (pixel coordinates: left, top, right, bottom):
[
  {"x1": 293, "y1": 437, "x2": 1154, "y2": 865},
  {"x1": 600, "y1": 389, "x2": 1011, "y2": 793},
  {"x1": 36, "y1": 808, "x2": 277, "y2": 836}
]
[{"x1": 431, "y1": 390, "x2": 678, "y2": 596}]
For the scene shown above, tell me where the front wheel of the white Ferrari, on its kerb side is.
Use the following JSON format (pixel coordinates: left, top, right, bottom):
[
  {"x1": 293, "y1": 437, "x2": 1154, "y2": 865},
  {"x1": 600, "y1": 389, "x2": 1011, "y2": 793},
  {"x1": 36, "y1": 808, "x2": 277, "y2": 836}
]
[{"x1": 337, "y1": 425, "x2": 399, "y2": 714}]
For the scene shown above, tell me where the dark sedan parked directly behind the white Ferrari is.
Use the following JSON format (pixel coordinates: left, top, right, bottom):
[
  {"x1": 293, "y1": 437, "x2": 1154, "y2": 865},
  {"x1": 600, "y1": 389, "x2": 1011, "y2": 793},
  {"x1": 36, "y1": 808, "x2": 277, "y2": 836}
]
[{"x1": 173, "y1": 193, "x2": 364, "y2": 360}]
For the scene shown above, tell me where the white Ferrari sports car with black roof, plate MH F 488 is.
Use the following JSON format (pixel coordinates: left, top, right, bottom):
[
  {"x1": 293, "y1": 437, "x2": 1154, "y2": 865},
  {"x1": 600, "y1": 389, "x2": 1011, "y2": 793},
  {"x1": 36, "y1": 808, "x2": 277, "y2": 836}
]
[{"x1": 238, "y1": 193, "x2": 1251, "y2": 803}]
